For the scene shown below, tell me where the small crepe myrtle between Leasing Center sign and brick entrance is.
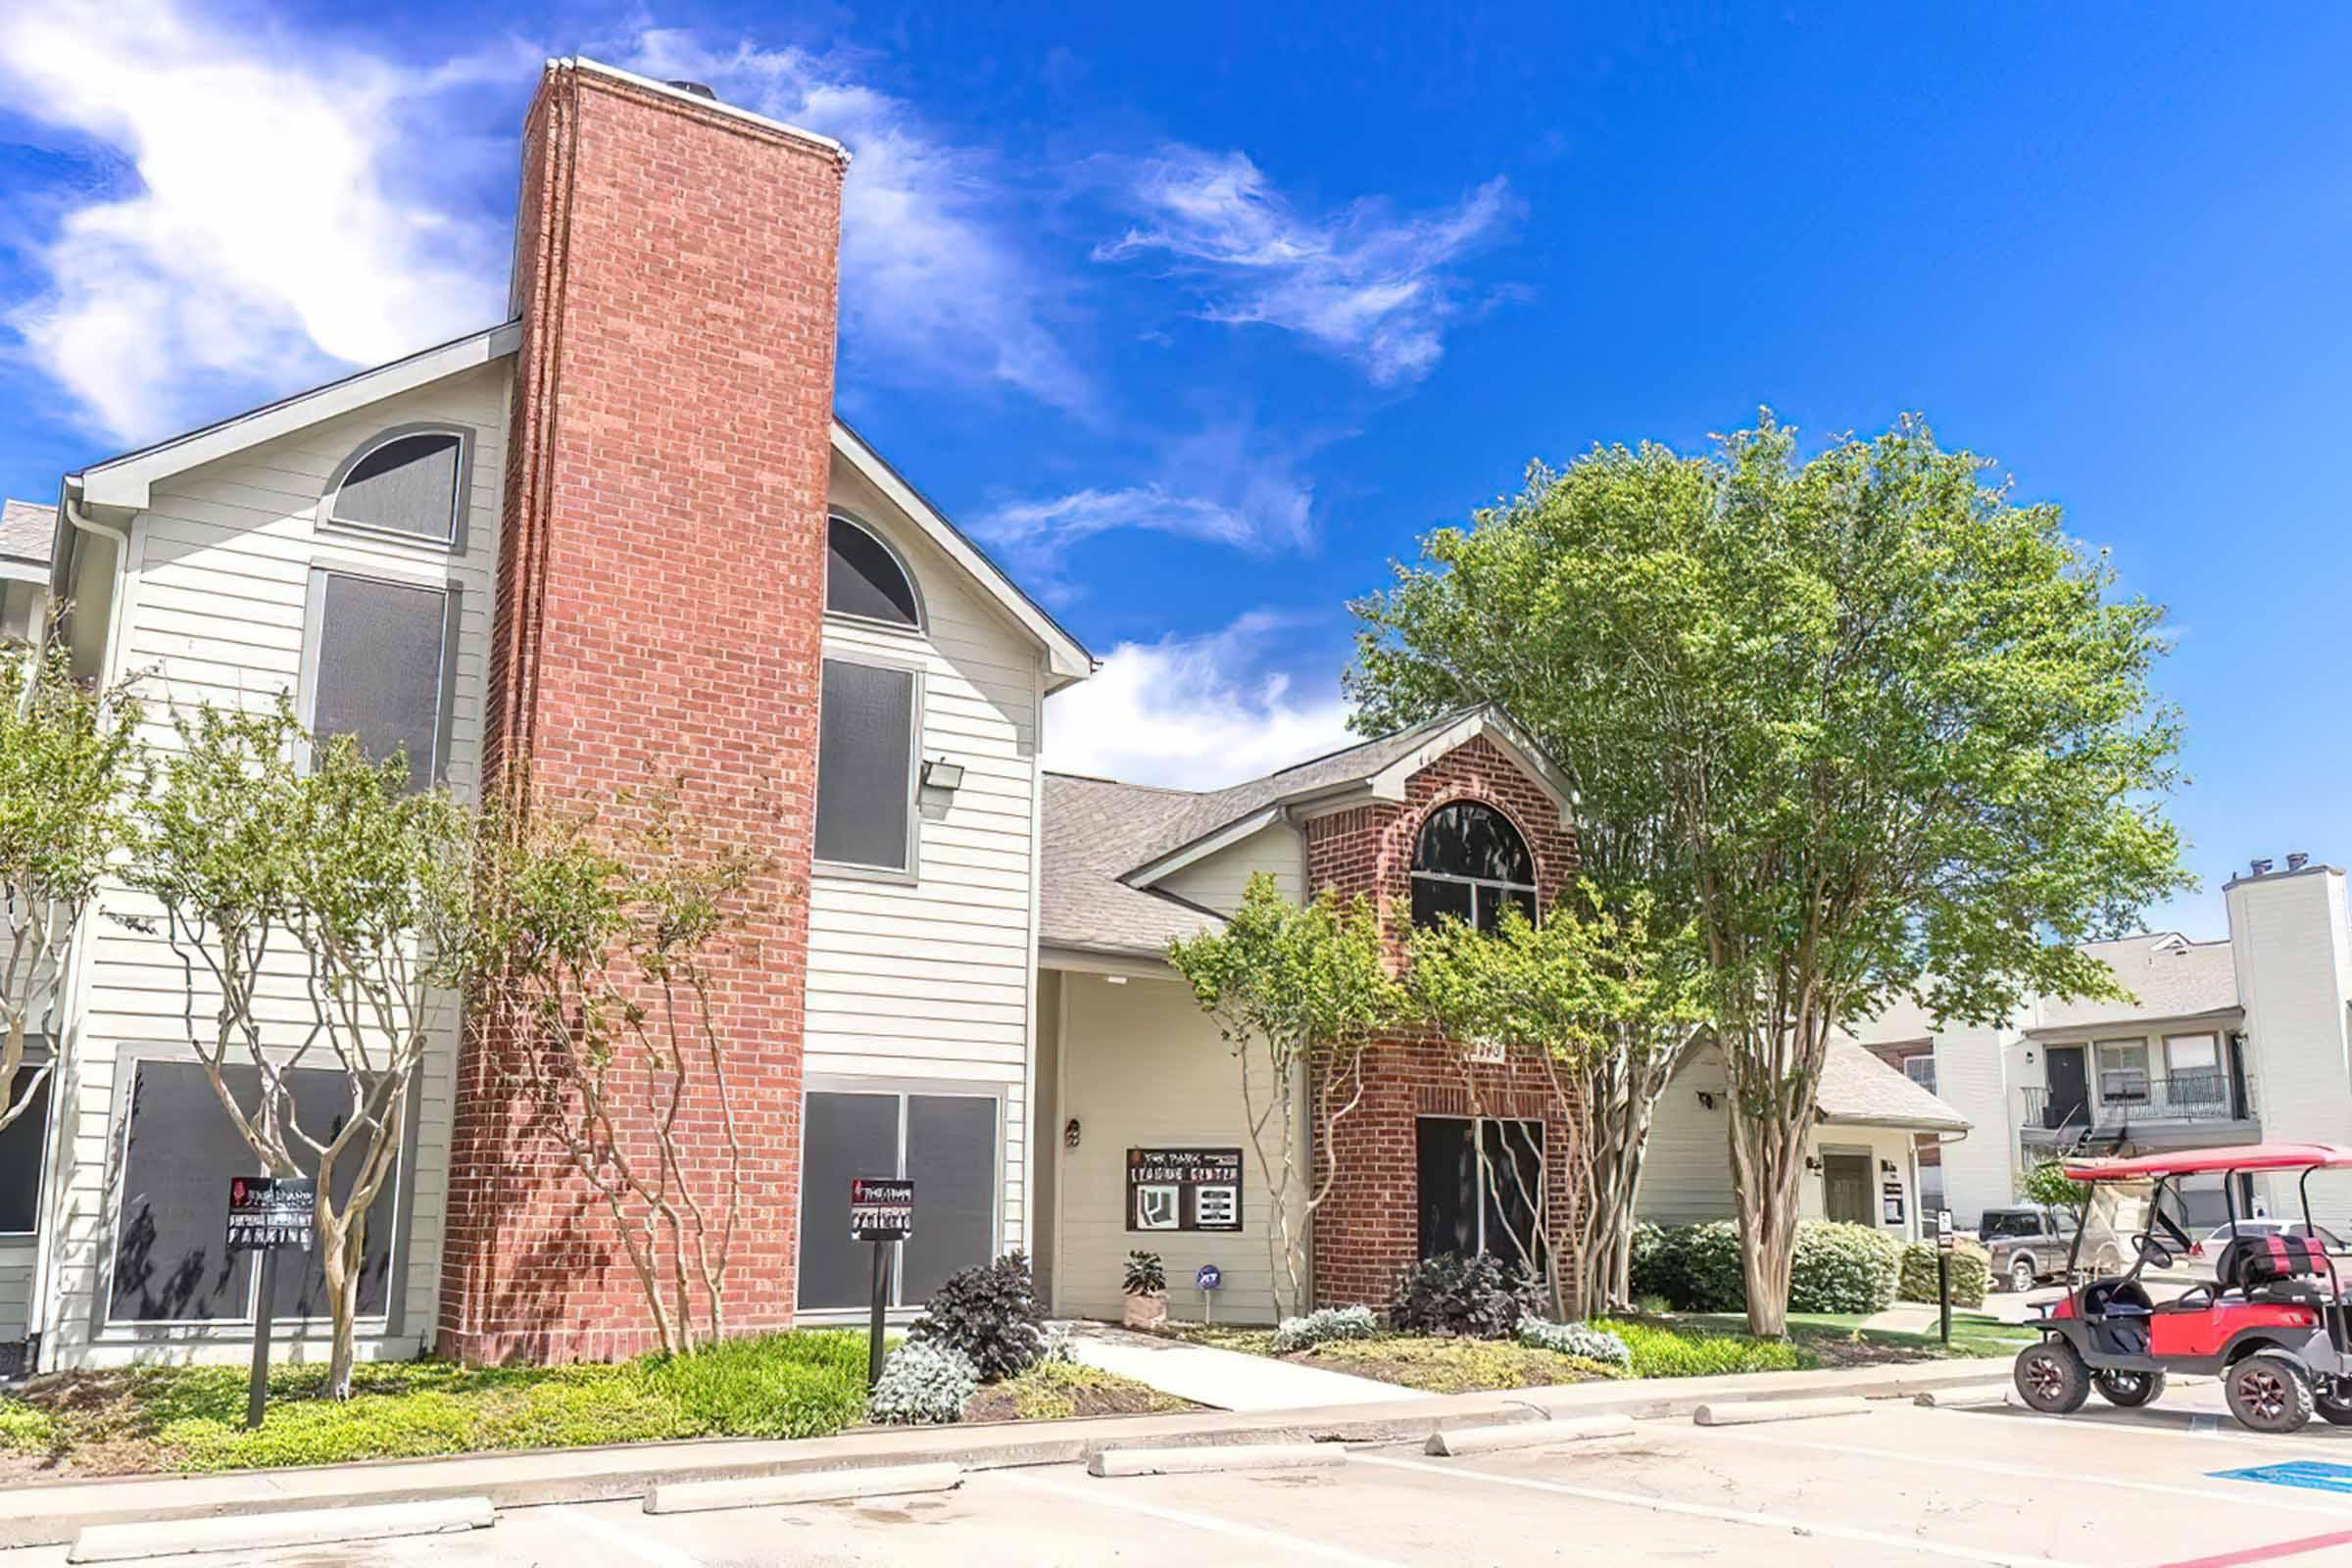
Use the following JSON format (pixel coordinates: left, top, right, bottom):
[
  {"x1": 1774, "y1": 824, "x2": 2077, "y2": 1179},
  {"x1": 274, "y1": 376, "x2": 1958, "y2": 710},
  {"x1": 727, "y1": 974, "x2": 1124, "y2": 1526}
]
[{"x1": 1169, "y1": 872, "x2": 1411, "y2": 1319}]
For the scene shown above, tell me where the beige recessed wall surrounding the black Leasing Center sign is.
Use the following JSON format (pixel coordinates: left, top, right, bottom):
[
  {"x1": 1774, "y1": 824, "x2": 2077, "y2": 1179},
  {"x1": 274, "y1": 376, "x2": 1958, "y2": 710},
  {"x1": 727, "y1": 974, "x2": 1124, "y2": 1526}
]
[{"x1": 1054, "y1": 973, "x2": 1305, "y2": 1324}]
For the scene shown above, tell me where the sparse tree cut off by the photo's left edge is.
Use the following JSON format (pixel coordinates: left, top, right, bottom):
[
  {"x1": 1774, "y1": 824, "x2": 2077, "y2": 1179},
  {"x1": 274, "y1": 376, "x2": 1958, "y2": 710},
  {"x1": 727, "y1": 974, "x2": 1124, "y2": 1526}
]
[{"x1": 0, "y1": 635, "x2": 141, "y2": 1128}]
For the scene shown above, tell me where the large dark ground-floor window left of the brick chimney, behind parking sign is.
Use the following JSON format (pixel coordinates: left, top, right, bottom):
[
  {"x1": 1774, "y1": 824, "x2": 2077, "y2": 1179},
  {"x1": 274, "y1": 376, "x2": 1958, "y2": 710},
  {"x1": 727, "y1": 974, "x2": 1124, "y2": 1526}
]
[{"x1": 108, "y1": 1062, "x2": 400, "y2": 1321}]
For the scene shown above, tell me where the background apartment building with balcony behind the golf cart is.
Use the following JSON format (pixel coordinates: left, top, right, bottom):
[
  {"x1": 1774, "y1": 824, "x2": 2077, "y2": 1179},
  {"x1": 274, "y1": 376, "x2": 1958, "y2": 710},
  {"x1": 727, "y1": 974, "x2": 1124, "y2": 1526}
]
[{"x1": 1856, "y1": 854, "x2": 2352, "y2": 1225}]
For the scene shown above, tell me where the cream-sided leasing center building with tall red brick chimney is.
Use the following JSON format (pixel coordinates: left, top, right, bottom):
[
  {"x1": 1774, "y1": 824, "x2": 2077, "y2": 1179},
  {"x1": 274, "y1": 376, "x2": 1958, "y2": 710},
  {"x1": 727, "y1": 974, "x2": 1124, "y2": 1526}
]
[{"x1": 0, "y1": 61, "x2": 1957, "y2": 1368}]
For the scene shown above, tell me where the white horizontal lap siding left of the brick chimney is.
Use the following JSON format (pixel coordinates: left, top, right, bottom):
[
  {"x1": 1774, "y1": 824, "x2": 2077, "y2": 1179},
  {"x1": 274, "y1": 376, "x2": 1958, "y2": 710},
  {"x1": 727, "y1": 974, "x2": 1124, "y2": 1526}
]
[{"x1": 42, "y1": 362, "x2": 508, "y2": 1363}]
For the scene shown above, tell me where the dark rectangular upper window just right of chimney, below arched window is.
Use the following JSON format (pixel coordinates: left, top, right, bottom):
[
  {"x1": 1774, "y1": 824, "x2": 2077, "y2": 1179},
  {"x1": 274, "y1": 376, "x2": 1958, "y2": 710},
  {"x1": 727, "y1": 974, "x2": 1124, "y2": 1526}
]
[{"x1": 816, "y1": 659, "x2": 915, "y2": 872}]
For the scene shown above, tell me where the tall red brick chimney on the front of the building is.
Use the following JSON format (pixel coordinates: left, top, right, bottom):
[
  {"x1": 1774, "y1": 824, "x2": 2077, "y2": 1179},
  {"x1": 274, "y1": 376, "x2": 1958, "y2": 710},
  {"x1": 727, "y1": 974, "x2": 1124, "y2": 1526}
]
[{"x1": 437, "y1": 64, "x2": 842, "y2": 1361}]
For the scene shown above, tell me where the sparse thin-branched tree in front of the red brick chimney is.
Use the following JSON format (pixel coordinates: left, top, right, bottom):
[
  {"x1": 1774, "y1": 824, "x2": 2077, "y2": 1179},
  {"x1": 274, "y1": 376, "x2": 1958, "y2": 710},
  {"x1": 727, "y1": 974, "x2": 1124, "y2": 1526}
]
[{"x1": 464, "y1": 785, "x2": 764, "y2": 1354}]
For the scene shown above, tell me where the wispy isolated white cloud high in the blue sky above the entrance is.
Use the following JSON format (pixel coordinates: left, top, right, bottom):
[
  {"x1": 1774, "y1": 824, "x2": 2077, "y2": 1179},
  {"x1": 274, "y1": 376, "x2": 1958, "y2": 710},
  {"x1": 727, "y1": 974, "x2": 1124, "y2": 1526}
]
[{"x1": 1094, "y1": 146, "x2": 1519, "y2": 385}]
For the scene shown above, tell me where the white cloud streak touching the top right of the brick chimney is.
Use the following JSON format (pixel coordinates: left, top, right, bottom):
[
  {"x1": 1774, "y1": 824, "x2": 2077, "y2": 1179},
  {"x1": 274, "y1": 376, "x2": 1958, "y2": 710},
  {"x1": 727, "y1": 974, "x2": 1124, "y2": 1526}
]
[{"x1": 628, "y1": 28, "x2": 1092, "y2": 409}]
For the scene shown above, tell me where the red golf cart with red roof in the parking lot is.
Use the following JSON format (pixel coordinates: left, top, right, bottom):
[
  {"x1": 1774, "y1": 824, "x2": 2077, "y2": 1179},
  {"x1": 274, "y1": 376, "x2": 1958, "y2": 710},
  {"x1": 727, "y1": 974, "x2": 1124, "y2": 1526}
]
[{"x1": 2016, "y1": 1143, "x2": 2352, "y2": 1432}]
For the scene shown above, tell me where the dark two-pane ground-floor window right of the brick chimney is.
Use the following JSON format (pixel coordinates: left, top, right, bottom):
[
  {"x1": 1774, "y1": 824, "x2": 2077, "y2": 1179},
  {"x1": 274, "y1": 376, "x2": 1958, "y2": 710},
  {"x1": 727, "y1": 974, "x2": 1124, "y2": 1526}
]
[{"x1": 800, "y1": 1089, "x2": 1002, "y2": 1312}]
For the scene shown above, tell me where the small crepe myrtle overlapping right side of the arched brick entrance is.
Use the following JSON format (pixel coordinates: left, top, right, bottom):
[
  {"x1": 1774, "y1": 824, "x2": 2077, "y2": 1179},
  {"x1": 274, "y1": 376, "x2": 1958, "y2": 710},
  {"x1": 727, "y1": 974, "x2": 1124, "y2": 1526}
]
[{"x1": 1406, "y1": 879, "x2": 1707, "y2": 1316}]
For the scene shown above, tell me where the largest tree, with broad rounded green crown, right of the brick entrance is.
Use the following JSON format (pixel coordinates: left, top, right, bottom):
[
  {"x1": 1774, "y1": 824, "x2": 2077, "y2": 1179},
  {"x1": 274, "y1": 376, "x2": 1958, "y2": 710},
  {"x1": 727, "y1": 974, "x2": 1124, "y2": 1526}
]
[{"x1": 1350, "y1": 412, "x2": 2187, "y2": 1336}]
